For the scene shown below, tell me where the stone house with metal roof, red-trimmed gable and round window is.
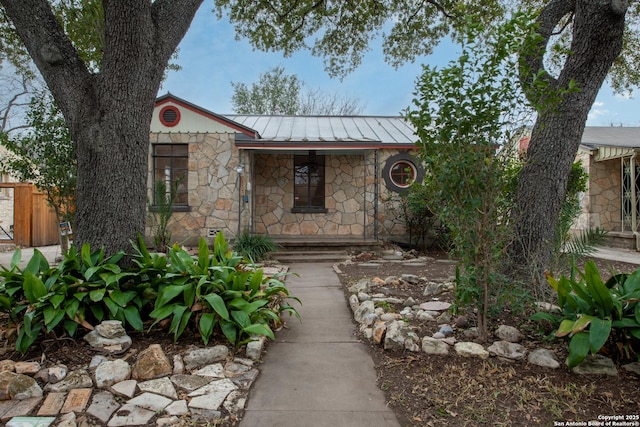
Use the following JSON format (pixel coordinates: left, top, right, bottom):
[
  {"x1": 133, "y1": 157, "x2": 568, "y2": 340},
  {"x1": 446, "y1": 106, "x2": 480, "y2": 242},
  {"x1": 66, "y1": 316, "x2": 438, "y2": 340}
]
[{"x1": 148, "y1": 94, "x2": 424, "y2": 244}]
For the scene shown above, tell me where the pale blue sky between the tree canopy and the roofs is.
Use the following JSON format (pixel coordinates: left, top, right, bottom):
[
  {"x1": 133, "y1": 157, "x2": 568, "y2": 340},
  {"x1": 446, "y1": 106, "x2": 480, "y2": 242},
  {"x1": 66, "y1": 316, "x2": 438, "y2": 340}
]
[{"x1": 158, "y1": 2, "x2": 640, "y2": 126}]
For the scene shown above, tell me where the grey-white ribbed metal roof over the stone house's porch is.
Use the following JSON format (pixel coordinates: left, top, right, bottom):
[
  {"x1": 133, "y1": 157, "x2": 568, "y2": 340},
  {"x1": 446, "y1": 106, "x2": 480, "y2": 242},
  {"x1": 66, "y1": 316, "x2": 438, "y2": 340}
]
[{"x1": 225, "y1": 115, "x2": 417, "y2": 148}]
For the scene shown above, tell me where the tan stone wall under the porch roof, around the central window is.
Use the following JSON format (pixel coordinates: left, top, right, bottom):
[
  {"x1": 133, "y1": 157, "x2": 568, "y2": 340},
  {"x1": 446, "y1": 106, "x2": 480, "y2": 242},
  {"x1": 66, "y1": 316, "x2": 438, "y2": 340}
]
[{"x1": 254, "y1": 151, "x2": 404, "y2": 239}]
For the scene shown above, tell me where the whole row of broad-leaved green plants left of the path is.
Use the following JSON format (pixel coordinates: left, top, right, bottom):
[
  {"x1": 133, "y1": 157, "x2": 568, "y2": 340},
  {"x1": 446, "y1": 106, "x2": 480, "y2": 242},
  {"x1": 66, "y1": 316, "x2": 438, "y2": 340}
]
[{"x1": 0, "y1": 233, "x2": 299, "y2": 353}]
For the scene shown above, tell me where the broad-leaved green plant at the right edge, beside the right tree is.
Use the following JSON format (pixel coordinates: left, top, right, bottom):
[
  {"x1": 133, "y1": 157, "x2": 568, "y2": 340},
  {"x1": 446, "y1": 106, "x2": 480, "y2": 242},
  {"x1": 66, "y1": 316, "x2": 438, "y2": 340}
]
[{"x1": 532, "y1": 260, "x2": 640, "y2": 368}]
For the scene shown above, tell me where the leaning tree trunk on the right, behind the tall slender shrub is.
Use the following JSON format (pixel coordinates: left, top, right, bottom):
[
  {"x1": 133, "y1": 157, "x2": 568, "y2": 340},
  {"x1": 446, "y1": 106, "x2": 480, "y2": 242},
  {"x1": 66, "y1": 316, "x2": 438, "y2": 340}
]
[{"x1": 511, "y1": 0, "x2": 628, "y2": 279}]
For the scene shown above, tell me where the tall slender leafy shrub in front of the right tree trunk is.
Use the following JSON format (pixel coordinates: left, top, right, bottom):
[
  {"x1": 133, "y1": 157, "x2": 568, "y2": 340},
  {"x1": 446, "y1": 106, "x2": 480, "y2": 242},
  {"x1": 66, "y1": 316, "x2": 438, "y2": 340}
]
[{"x1": 408, "y1": 13, "x2": 531, "y2": 341}]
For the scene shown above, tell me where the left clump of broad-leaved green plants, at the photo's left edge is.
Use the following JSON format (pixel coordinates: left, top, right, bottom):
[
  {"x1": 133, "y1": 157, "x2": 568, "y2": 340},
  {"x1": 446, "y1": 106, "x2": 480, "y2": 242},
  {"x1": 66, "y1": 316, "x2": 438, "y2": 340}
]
[{"x1": 0, "y1": 244, "x2": 142, "y2": 353}]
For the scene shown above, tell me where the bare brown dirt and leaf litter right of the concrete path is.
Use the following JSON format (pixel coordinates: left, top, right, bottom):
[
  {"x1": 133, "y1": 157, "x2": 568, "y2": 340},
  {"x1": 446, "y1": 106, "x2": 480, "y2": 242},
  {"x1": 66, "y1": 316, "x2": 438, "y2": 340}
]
[{"x1": 339, "y1": 254, "x2": 640, "y2": 426}]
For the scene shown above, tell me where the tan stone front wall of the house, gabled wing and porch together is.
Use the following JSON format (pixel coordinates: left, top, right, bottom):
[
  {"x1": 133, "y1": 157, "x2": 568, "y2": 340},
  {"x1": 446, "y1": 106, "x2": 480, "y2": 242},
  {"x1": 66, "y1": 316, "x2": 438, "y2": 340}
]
[{"x1": 147, "y1": 133, "x2": 405, "y2": 244}]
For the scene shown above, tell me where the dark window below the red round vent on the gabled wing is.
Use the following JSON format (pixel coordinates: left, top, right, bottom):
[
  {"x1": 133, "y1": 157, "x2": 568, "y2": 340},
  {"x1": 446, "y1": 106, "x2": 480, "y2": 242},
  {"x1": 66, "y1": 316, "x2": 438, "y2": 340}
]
[{"x1": 153, "y1": 144, "x2": 189, "y2": 210}]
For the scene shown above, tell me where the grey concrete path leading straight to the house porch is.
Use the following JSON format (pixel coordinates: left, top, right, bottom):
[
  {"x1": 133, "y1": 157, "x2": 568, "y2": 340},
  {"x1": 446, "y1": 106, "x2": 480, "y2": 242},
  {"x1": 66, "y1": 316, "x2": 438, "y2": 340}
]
[{"x1": 240, "y1": 263, "x2": 400, "y2": 427}]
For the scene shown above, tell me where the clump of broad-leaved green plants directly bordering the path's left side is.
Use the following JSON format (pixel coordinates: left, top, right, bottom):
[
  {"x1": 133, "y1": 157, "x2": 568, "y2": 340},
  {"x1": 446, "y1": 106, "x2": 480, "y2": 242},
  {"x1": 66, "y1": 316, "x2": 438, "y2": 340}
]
[{"x1": 150, "y1": 233, "x2": 299, "y2": 345}]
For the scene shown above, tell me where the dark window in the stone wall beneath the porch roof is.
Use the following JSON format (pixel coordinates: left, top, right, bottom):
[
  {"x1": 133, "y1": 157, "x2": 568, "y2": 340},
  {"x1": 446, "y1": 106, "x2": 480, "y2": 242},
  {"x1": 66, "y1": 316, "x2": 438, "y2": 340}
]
[{"x1": 291, "y1": 151, "x2": 327, "y2": 212}]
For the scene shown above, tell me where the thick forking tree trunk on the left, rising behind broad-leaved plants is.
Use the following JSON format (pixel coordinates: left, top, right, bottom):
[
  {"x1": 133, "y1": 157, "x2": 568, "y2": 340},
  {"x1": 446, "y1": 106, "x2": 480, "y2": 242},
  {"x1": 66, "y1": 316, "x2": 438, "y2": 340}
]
[{"x1": 0, "y1": 0, "x2": 202, "y2": 254}]
